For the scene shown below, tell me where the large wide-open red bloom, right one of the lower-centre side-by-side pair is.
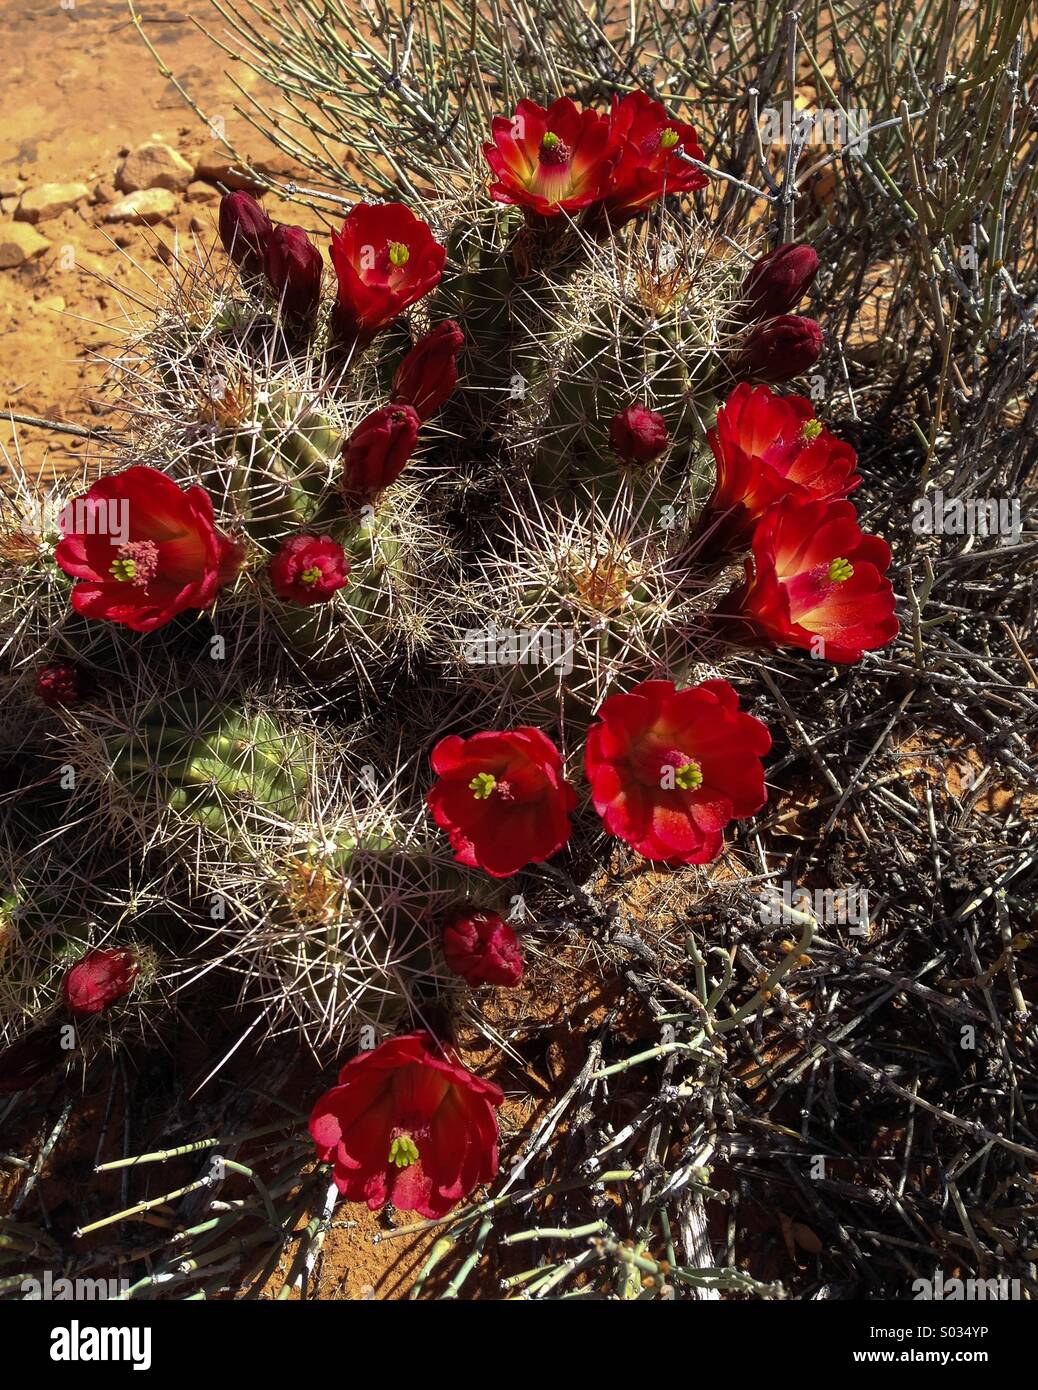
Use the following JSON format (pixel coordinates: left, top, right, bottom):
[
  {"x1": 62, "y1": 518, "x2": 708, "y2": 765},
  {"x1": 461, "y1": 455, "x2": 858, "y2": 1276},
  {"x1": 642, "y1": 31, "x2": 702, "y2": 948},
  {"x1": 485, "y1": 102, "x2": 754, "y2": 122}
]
[{"x1": 584, "y1": 681, "x2": 771, "y2": 865}]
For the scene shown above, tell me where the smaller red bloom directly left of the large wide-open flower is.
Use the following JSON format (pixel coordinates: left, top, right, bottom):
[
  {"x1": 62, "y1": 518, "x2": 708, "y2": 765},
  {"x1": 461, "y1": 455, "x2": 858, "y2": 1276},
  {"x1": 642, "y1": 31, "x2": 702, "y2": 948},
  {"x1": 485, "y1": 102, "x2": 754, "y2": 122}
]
[{"x1": 425, "y1": 728, "x2": 577, "y2": 878}]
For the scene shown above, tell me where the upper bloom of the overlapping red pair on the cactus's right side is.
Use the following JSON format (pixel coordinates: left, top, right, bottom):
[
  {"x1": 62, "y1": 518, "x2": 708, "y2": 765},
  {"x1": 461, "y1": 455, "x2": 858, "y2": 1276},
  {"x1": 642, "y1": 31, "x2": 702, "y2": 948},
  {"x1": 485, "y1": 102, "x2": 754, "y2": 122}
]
[{"x1": 700, "y1": 381, "x2": 862, "y2": 545}]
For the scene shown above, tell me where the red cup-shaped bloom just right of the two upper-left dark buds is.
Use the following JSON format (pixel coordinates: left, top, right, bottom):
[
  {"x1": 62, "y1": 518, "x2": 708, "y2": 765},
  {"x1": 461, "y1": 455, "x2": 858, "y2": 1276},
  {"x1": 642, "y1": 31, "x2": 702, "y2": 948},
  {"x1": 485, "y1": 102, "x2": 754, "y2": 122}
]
[{"x1": 331, "y1": 203, "x2": 447, "y2": 343}]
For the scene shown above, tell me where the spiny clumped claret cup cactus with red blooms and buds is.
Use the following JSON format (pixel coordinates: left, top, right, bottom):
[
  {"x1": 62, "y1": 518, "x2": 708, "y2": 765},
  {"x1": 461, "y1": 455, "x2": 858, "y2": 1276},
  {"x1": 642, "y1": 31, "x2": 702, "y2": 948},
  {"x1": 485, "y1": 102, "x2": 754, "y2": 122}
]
[{"x1": 3, "y1": 73, "x2": 896, "y2": 1212}]
